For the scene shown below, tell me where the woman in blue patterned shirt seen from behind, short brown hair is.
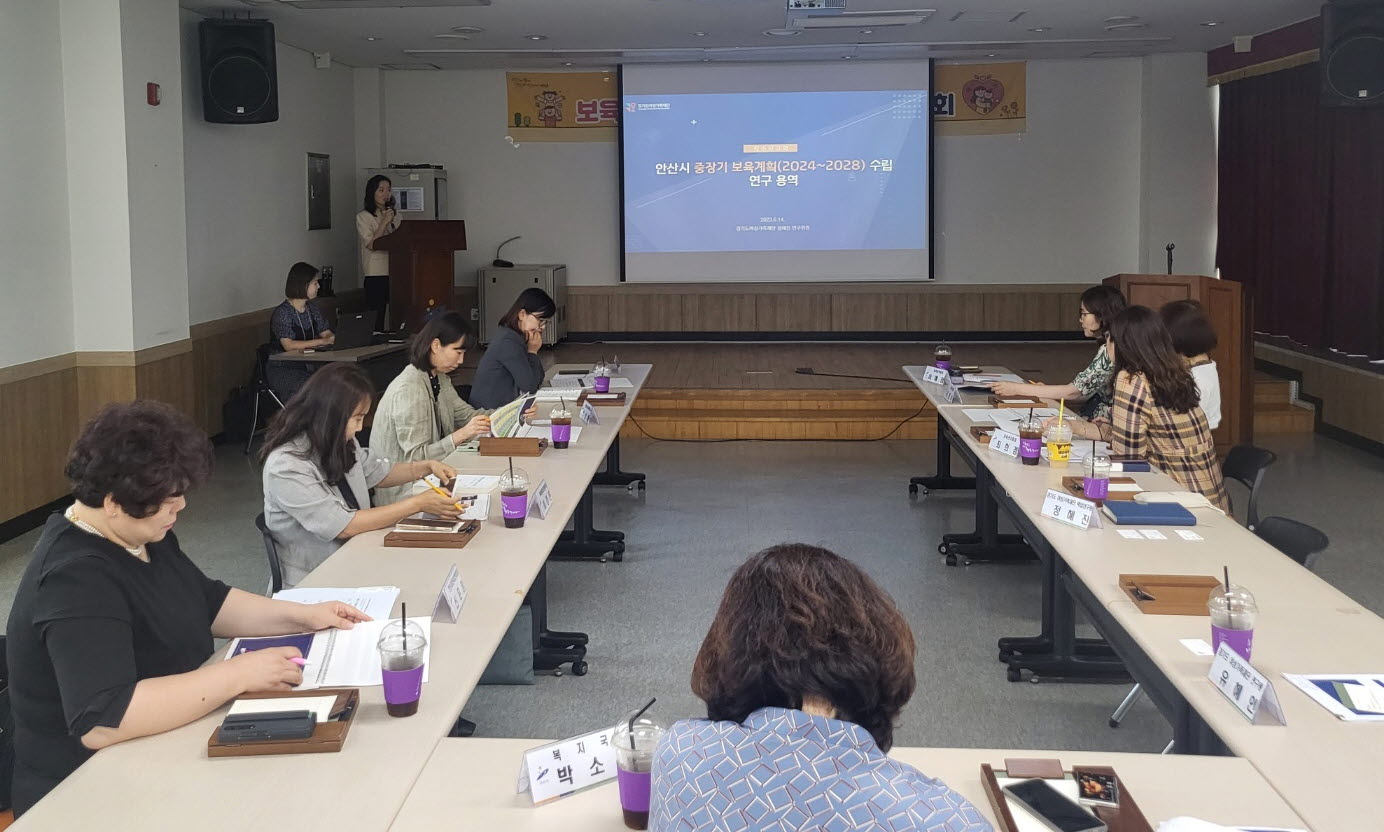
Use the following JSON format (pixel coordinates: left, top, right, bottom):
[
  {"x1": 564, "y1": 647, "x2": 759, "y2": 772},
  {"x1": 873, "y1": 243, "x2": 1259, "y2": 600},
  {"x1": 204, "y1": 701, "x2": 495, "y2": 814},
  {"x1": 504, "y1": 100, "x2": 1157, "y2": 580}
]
[{"x1": 649, "y1": 544, "x2": 991, "y2": 832}]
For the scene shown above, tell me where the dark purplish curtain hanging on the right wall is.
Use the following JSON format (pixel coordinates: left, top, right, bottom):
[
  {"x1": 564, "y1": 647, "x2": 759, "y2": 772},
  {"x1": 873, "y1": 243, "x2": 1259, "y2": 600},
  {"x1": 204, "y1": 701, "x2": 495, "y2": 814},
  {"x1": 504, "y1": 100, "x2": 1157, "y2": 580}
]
[{"x1": 1217, "y1": 64, "x2": 1384, "y2": 357}]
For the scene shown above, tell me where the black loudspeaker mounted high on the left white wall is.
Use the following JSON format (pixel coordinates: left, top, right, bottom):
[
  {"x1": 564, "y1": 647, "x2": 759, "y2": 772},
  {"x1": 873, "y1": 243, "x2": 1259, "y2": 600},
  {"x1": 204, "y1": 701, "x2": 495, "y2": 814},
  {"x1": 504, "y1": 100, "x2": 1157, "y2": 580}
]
[{"x1": 197, "y1": 21, "x2": 278, "y2": 125}]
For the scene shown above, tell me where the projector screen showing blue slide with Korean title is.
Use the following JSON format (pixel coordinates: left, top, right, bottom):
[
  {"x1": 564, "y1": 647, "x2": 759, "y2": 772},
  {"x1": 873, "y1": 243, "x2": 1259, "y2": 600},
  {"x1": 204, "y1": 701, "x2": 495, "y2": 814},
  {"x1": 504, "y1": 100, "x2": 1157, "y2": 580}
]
[{"x1": 620, "y1": 61, "x2": 931, "y2": 282}]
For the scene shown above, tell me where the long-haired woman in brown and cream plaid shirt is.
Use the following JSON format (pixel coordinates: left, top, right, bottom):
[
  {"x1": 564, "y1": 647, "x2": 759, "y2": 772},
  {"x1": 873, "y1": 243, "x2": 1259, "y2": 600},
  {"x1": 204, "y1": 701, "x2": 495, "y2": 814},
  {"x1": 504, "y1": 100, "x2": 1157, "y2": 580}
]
[{"x1": 1049, "y1": 306, "x2": 1230, "y2": 512}]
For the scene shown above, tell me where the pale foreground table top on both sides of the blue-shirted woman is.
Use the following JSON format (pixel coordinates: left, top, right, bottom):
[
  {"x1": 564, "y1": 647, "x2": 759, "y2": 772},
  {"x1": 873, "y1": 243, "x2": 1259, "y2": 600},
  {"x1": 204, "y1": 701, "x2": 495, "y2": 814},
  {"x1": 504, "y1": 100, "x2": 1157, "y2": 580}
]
[{"x1": 390, "y1": 739, "x2": 1304, "y2": 832}]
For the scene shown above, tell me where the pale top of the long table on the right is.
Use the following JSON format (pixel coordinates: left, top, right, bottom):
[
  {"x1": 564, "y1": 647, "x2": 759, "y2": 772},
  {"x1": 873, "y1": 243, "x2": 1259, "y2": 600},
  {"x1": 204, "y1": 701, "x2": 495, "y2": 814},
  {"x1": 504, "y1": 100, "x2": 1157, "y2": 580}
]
[{"x1": 919, "y1": 359, "x2": 1384, "y2": 829}]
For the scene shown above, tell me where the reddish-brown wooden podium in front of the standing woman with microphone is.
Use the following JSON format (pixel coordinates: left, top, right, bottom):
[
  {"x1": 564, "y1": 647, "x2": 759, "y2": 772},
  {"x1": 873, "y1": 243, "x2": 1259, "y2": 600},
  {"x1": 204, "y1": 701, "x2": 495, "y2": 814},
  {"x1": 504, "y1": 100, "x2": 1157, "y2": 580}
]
[{"x1": 375, "y1": 220, "x2": 466, "y2": 332}]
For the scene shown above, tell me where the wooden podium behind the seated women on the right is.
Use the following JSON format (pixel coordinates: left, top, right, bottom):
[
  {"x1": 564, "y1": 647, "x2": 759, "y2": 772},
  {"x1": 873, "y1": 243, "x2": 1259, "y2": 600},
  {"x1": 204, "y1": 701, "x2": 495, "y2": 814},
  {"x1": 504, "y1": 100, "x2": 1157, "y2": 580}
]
[{"x1": 1102, "y1": 274, "x2": 1254, "y2": 453}]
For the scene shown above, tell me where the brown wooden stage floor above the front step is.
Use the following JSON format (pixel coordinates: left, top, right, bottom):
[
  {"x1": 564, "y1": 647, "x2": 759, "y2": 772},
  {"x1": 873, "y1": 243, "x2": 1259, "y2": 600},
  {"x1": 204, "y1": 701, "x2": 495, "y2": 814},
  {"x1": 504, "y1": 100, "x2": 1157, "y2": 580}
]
[{"x1": 539, "y1": 341, "x2": 1095, "y2": 390}]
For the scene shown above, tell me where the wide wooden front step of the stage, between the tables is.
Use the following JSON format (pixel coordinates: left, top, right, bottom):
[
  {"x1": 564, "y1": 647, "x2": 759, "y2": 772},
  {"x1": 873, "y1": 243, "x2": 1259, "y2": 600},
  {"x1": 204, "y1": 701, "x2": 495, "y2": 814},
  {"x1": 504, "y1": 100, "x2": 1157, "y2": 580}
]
[{"x1": 620, "y1": 389, "x2": 937, "y2": 440}]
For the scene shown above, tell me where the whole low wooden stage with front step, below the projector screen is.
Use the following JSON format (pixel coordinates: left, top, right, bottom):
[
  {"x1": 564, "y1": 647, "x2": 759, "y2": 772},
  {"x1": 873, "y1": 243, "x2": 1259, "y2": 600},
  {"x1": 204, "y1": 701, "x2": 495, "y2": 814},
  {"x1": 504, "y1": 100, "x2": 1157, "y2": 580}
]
[{"x1": 544, "y1": 342, "x2": 1095, "y2": 440}]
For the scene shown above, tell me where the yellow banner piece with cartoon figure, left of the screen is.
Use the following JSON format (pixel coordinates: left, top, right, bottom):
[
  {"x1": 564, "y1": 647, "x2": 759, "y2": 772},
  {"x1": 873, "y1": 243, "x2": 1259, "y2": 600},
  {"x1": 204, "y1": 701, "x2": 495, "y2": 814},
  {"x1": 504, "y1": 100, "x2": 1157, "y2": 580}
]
[{"x1": 505, "y1": 72, "x2": 620, "y2": 141}]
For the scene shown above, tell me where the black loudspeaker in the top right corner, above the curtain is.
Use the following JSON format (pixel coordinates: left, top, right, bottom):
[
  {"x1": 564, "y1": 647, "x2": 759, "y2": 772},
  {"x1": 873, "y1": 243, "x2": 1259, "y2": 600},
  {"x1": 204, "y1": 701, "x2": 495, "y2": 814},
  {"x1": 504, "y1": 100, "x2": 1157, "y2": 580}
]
[{"x1": 1320, "y1": 0, "x2": 1384, "y2": 107}]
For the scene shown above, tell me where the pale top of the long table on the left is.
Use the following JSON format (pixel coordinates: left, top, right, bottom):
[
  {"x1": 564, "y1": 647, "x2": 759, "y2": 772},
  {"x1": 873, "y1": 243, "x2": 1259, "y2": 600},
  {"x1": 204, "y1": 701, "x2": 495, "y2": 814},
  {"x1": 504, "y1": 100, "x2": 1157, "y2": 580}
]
[{"x1": 12, "y1": 364, "x2": 650, "y2": 832}]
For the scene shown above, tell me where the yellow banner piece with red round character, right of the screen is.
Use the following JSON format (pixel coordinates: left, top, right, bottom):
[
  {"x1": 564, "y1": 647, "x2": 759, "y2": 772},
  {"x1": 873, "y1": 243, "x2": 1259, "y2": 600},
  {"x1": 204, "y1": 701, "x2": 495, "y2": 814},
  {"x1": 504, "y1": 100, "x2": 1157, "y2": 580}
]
[{"x1": 933, "y1": 61, "x2": 1028, "y2": 136}]
